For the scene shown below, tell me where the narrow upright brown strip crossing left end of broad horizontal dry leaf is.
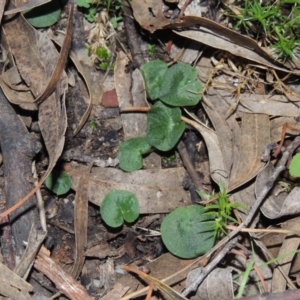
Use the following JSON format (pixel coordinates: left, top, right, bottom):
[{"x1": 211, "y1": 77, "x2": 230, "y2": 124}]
[{"x1": 71, "y1": 163, "x2": 93, "y2": 279}]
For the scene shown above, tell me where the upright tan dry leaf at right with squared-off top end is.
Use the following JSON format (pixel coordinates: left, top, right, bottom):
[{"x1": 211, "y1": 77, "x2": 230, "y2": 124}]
[{"x1": 228, "y1": 113, "x2": 270, "y2": 192}]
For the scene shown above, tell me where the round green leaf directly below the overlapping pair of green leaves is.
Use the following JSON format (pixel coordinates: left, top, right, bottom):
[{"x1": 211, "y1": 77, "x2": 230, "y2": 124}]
[{"x1": 147, "y1": 102, "x2": 185, "y2": 151}]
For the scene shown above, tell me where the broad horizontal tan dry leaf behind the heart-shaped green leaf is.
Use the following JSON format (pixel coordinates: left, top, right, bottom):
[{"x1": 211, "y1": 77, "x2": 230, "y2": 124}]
[{"x1": 64, "y1": 163, "x2": 190, "y2": 214}]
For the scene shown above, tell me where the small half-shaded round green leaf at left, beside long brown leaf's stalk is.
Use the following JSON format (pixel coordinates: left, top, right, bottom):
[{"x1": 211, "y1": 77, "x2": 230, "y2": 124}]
[{"x1": 45, "y1": 170, "x2": 72, "y2": 196}]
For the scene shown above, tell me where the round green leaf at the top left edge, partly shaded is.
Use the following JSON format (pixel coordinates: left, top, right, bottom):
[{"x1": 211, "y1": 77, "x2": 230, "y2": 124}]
[{"x1": 24, "y1": 0, "x2": 61, "y2": 28}]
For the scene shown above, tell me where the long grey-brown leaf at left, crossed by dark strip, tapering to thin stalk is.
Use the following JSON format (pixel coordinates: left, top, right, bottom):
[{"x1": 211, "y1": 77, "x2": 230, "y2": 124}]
[{"x1": 0, "y1": 4, "x2": 73, "y2": 218}]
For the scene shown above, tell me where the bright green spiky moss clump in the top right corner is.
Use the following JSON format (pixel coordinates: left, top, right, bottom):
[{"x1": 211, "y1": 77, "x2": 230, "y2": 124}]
[{"x1": 228, "y1": 0, "x2": 300, "y2": 61}]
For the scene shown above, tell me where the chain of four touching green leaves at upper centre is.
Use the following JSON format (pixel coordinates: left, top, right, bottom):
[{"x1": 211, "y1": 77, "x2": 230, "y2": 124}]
[{"x1": 119, "y1": 60, "x2": 202, "y2": 172}]
